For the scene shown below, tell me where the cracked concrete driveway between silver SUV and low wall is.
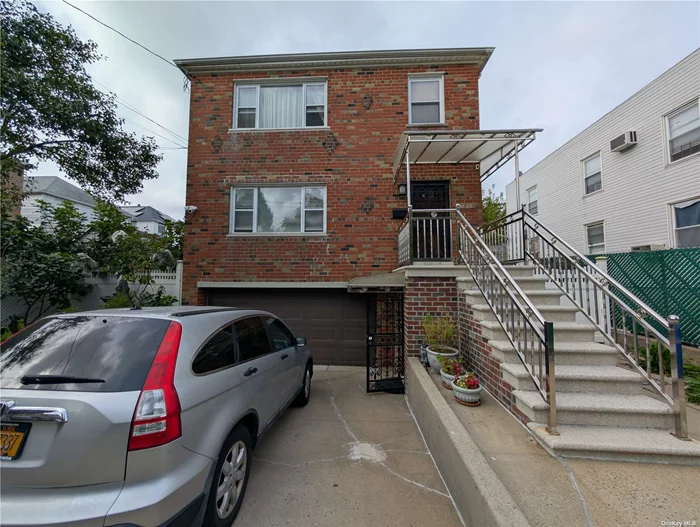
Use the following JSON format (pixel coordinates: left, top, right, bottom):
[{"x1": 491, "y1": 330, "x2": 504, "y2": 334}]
[{"x1": 234, "y1": 366, "x2": 461, "y2": 527}]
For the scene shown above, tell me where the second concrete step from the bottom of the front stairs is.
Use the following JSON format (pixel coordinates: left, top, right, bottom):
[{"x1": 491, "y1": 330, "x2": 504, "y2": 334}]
[{"x1": 513, "y1": 390, "x2": 673, "y2": 430}]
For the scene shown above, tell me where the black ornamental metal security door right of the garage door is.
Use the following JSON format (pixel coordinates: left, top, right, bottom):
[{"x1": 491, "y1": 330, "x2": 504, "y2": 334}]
[{"x1": 367, "y1": 293, "x2": 404, "y2": 393}]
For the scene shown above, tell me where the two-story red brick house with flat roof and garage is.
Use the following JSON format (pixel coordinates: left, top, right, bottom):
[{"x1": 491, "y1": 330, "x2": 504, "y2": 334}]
[{"x1": 176, "y1": 48, "x2": 534, "y2": 374}]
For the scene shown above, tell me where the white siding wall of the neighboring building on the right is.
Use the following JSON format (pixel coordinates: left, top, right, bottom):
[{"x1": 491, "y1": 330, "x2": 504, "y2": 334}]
[{"x1": 506, "y1": 49, "x2": 700, "y2": 253}]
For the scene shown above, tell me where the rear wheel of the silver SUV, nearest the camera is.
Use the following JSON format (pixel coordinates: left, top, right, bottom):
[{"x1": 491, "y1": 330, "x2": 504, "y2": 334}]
[{"x1": 202, "y1": 425, "x2": 253, "y2": 527}]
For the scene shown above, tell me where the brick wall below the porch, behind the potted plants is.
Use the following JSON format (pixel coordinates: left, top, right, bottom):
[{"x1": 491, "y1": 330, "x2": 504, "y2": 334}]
[{"x1": 403, "y1": 276, "x2": 457, "y2": 356}]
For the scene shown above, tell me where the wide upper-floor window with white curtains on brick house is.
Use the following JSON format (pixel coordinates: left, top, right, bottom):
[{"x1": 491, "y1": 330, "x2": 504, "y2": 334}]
[{"x1": 233, "y1": 81, "x2": 328, "y2": 130}]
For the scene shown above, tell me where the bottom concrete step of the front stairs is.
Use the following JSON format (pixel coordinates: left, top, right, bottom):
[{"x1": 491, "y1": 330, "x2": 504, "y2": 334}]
[{"x1": 528, "y1": 423, "x2": 700, "y2": 466}]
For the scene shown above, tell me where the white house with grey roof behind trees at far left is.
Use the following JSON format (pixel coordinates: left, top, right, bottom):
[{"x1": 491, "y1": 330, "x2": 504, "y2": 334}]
[{"x1": 20, "y1": 176, "x2": 97, "y2": 225}]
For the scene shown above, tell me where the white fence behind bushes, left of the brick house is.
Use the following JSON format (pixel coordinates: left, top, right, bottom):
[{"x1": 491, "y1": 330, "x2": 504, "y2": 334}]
[{"x1": 0, "y1": 260, "x2": 182, "y2": 326}]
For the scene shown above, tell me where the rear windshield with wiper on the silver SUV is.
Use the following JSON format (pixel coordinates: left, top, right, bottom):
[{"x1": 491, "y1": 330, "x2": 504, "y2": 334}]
[{"x1": 0, "y1": 316, "x2": 170, "y2": 392}]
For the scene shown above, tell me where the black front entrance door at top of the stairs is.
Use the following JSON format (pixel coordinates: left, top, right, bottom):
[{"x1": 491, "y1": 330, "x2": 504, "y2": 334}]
[{"x1": 411, "y1": 181, "x2": 452, "y2": 261}]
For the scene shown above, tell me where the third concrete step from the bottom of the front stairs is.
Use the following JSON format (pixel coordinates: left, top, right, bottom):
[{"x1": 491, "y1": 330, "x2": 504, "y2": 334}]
[{"x1": 501, "y1": 362, "x2": 644, "y2": 395}]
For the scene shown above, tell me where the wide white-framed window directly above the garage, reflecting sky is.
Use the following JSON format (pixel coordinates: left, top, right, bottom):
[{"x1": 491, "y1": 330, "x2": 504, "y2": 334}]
[{"x1": 231, "y1": 185, "x2": 326, "y2": 234}]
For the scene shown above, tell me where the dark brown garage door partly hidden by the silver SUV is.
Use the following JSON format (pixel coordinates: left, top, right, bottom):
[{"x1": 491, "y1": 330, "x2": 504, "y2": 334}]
[{"x1": 208, "y1": 289, "x2": 367, "y2": 366}]
